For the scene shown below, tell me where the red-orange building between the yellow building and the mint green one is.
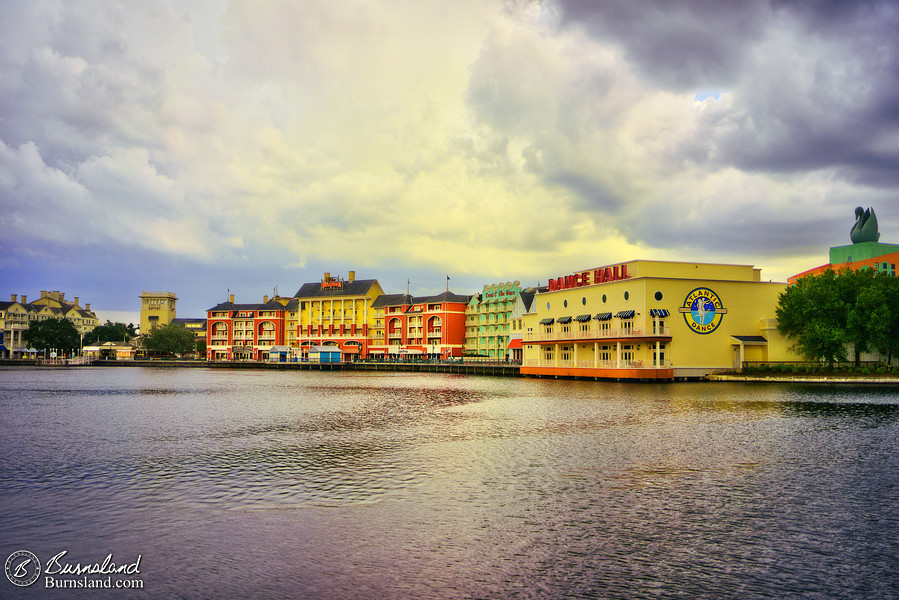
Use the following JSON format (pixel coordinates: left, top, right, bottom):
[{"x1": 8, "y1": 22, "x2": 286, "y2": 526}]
[{"x1": 371, "y1": 291, "x2": 471, "y2": 360}]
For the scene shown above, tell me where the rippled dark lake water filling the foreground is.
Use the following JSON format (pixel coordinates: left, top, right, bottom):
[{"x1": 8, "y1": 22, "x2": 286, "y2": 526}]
[{"x1": 0, "y1": 367, "x2": 899, "y2": 600}]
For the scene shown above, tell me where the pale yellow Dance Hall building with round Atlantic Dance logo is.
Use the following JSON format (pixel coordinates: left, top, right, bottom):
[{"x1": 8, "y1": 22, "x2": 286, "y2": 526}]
[{"x1": 521, "y1": 260, "x2": 798, "y2": 380}]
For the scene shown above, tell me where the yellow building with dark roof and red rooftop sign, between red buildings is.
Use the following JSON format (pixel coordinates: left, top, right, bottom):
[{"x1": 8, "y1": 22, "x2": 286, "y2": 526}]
[{"x1": 288, "y1": 271, "x2": 384, "y2": 361}]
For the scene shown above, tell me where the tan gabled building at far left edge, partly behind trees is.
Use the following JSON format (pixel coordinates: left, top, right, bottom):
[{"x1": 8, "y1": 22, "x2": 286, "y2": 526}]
[{"x1": 0, "y1": 290, "x2": 98, "y2": 358}]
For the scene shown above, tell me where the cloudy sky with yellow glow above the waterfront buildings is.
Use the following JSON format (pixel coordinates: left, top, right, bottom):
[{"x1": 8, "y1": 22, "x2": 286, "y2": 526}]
[{"x1": 0, "y1": 0, "x2": 899, "y2": 320}]
